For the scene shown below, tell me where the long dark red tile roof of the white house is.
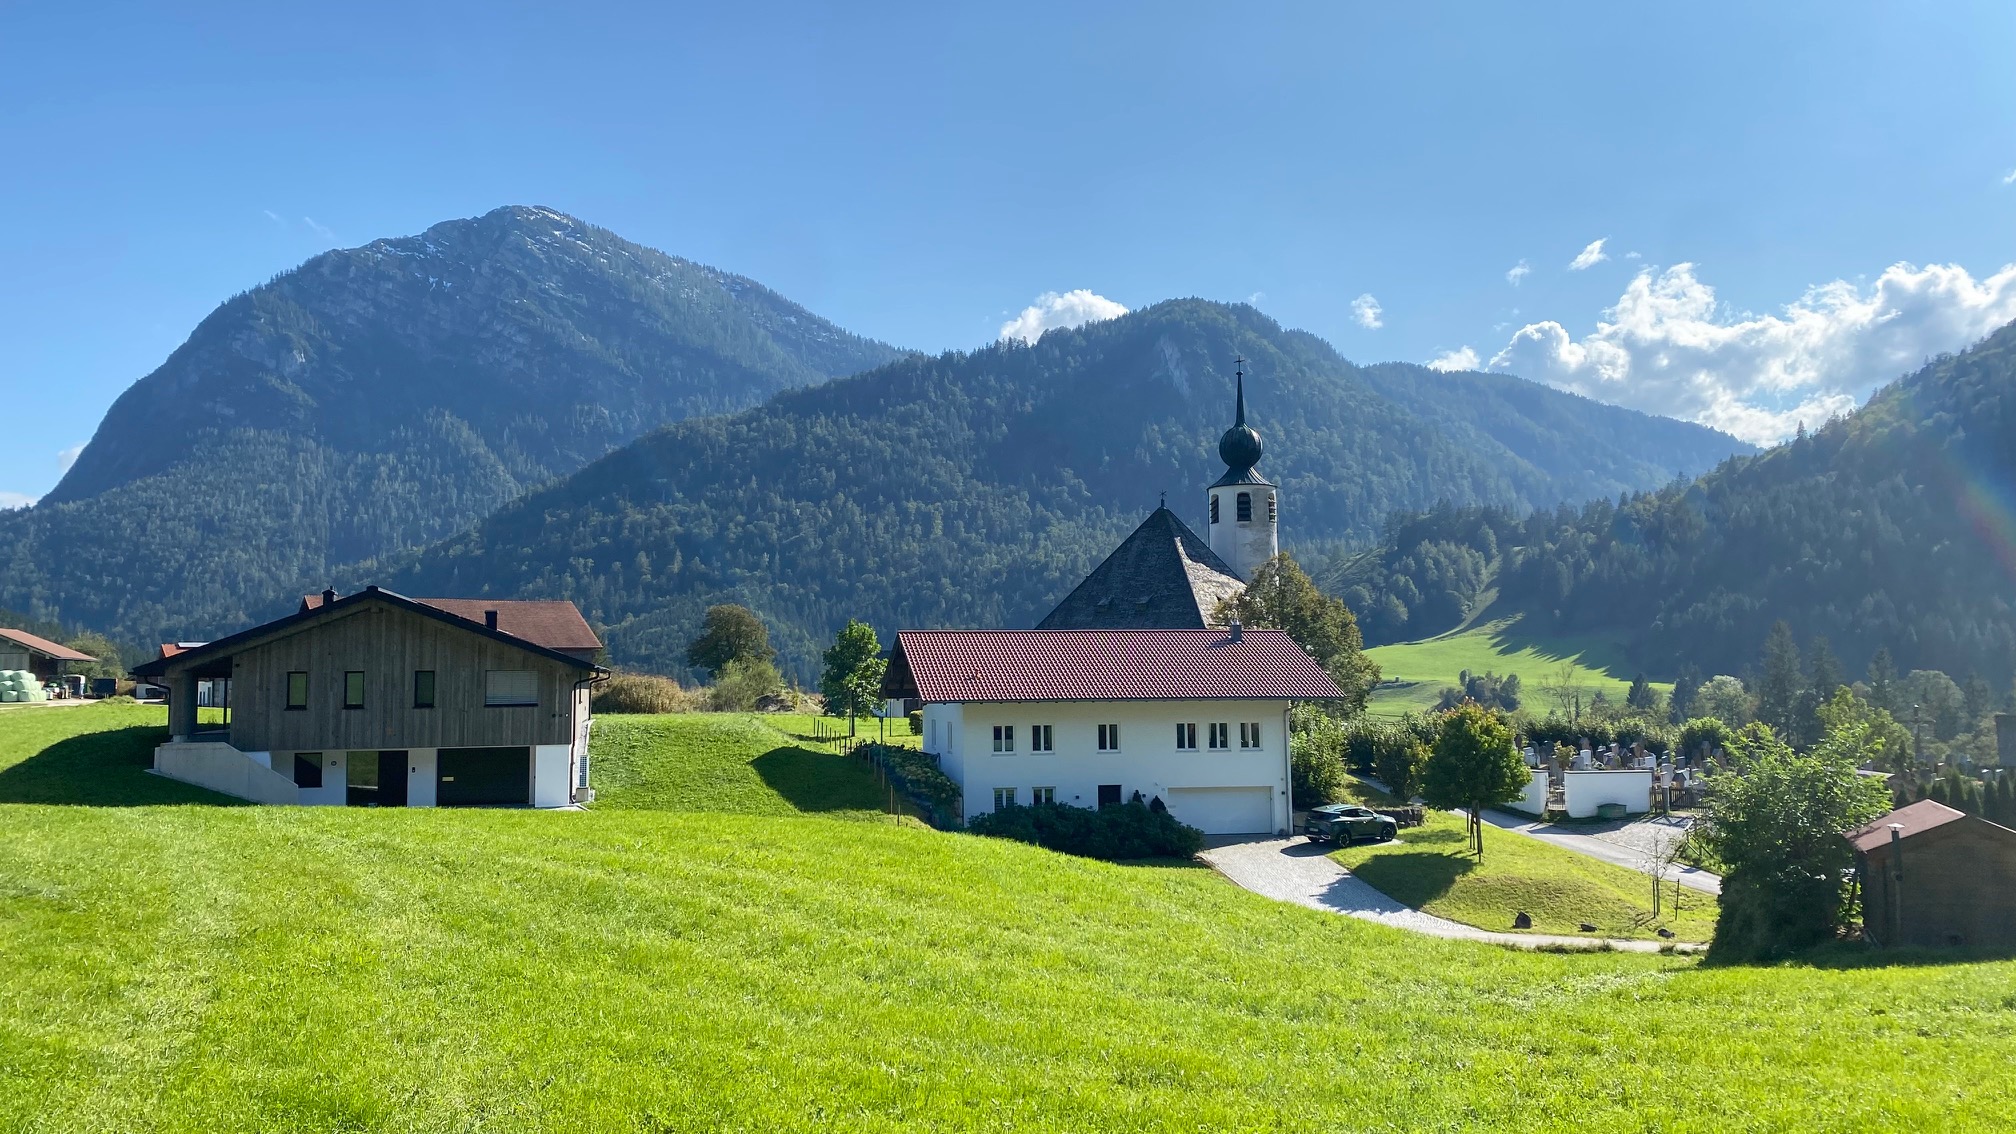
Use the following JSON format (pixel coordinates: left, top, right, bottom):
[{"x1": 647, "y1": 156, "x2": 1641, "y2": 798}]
[{"x1": 883, "y1": 630, "x2": 1343, "y2": 702}]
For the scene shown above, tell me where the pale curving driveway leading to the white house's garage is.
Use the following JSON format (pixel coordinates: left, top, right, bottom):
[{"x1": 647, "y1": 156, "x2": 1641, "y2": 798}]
[{"x1": 1200, "y1": 835, "x2": 1699, "y2": 952}]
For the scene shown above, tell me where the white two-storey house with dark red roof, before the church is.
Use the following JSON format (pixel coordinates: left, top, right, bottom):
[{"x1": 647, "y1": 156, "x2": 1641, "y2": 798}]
[{"x1": 883, "y1": 626, "x2": 1341, "y2": 835}]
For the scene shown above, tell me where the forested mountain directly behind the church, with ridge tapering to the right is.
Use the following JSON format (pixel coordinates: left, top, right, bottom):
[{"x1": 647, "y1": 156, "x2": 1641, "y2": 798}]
[{"x1": 374, "y1": 301, "x2": 1744, "y2": 674}]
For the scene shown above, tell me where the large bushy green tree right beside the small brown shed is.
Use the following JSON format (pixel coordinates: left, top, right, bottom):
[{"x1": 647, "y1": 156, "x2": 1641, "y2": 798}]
[{"x1": 1706, "y1": 722, "x2": 1889, "y2": 960}]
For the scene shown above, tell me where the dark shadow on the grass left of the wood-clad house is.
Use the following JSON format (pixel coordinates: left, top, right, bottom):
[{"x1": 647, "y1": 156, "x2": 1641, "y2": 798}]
[{"x1": 0, "y1": 710, "x2": 246, "y2": 807}]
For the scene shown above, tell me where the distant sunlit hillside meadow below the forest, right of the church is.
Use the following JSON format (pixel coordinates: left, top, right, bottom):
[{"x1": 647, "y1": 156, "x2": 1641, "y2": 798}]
[{"x1": 1365, "y1": 615, "x2": 1673, "y2": 716}]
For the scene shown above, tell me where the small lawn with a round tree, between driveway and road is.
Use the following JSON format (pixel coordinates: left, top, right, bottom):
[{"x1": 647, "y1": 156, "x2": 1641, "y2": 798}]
[{"x1": 1331, "y1": 785, "x2": 1716, "y2": 940}]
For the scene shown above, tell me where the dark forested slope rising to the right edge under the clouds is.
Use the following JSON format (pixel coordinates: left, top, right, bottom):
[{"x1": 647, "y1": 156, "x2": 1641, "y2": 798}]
[{"x1": 1331, "y1": 325, "x2": 2016, "y2": 688}]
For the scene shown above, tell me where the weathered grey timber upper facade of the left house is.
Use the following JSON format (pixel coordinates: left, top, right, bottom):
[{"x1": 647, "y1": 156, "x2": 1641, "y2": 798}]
[{"x1": 161, "y1": 599, "x2": 593, "y2": 753}]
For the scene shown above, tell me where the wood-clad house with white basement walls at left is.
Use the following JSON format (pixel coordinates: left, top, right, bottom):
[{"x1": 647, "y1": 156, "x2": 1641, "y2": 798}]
[{"x1": 133, "y1": 587, "x2": 607, "y2": 807}]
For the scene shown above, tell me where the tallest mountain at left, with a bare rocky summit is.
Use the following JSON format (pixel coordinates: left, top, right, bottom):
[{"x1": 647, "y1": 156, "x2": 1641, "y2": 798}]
[{"x1": 0, "y1": 206, "x2": 899, "y2": 640}]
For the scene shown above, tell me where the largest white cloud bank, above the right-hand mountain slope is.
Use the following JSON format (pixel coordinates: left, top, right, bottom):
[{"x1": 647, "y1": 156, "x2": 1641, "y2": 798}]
[{"x1": 1490, "y1": 264, "x2": 2016, "y2": 444}]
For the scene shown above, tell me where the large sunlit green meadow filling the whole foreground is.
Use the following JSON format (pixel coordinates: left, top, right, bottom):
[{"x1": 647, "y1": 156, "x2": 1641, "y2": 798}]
[{"x1": 0, "y1": 708, "x2": 2016, "y2": 1132}]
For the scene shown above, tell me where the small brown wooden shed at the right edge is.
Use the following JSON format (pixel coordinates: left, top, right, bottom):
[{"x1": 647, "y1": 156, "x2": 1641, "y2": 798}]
[{"x1": 1849, "y1": 799, "x2": 2016, "y2": 948}]
